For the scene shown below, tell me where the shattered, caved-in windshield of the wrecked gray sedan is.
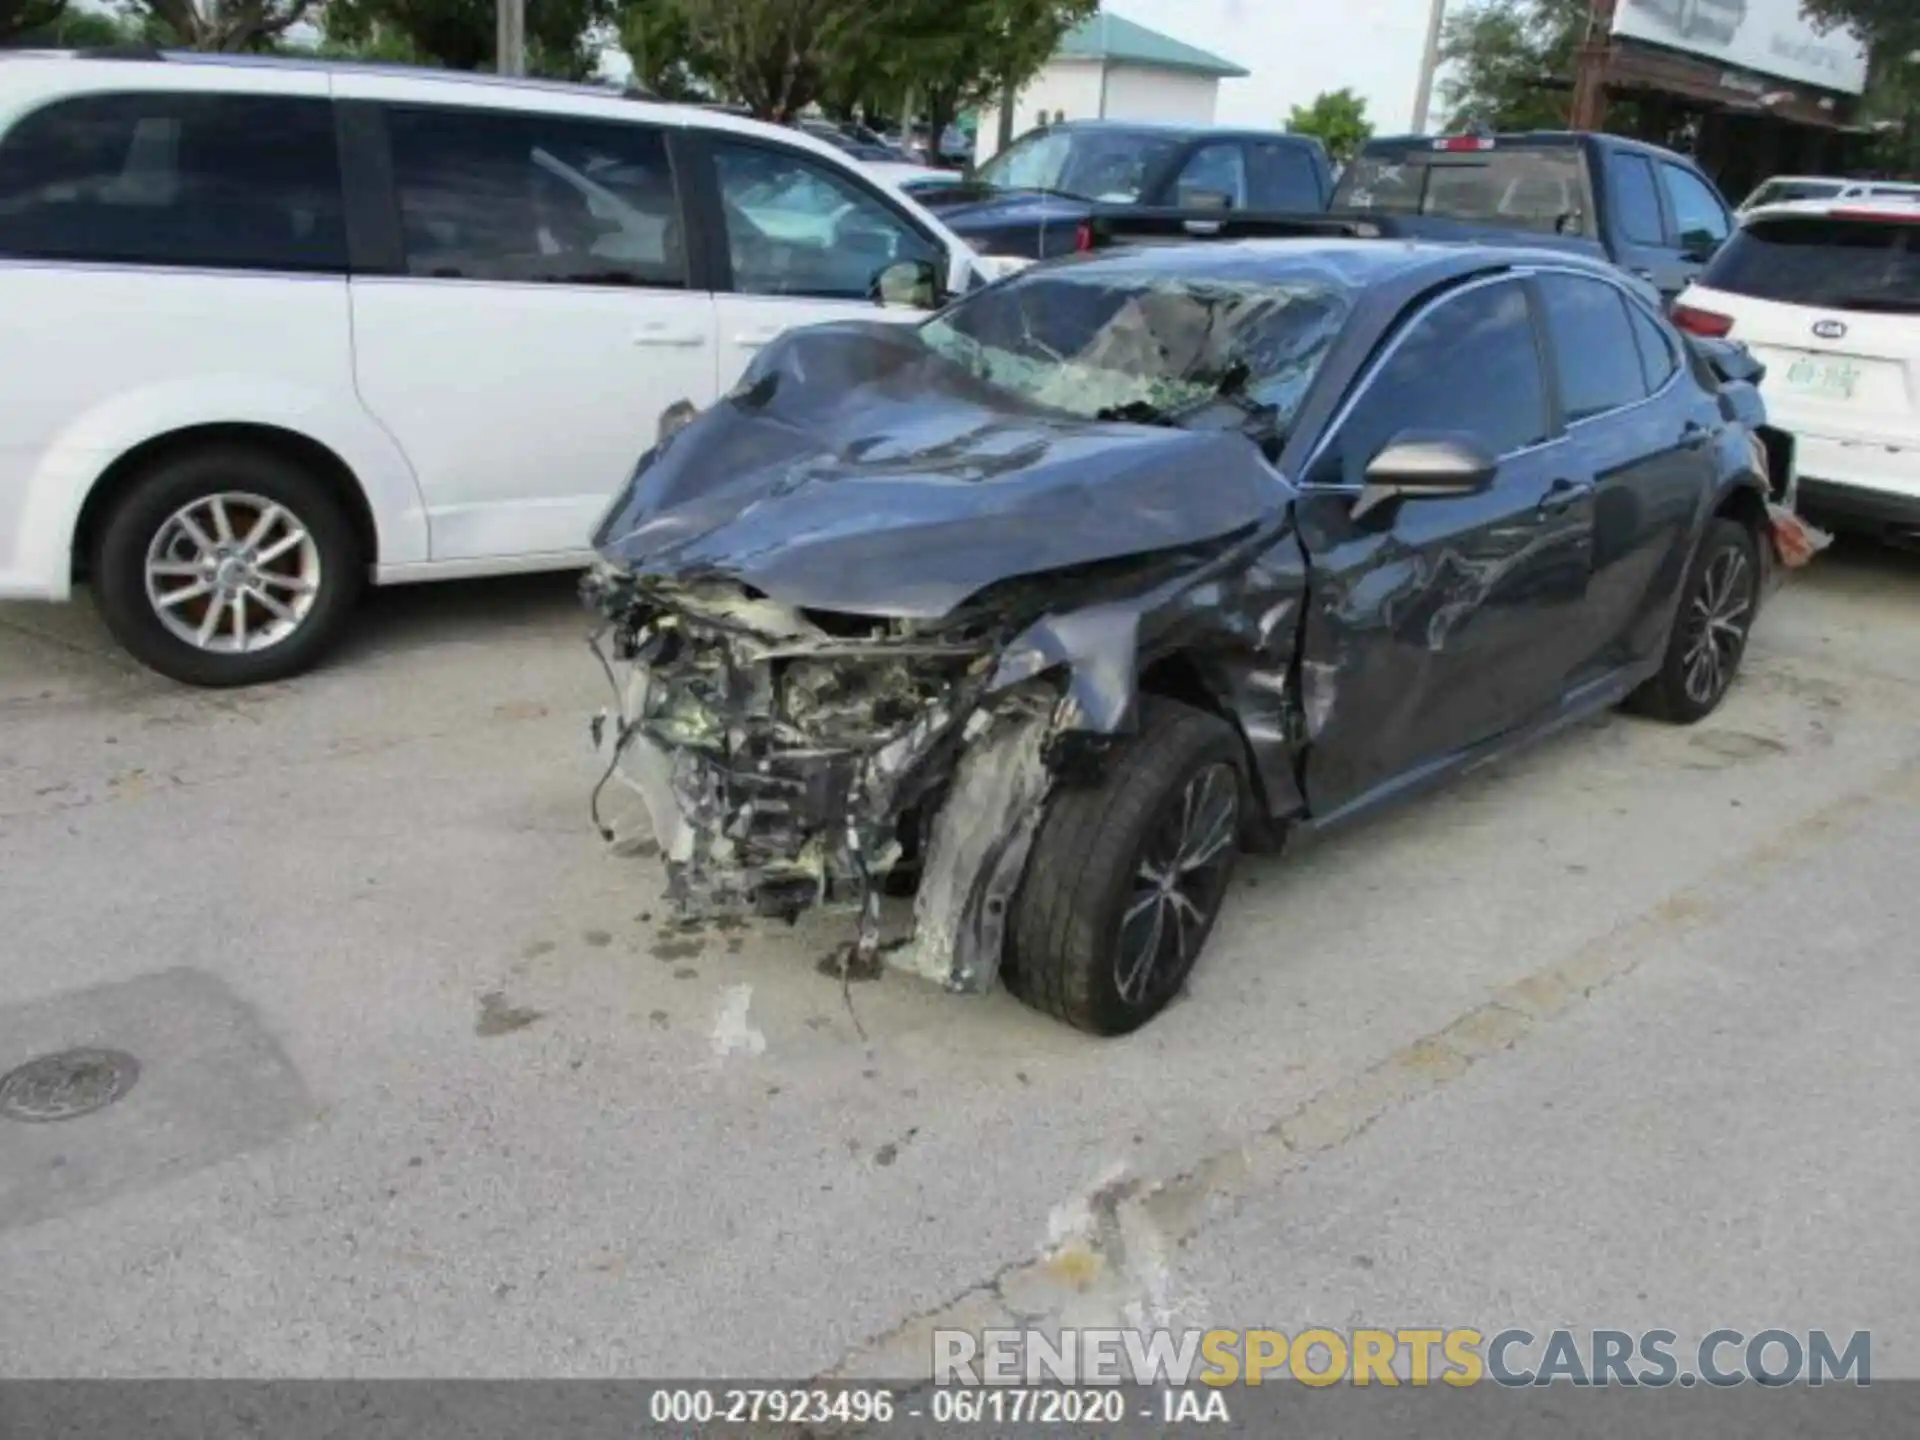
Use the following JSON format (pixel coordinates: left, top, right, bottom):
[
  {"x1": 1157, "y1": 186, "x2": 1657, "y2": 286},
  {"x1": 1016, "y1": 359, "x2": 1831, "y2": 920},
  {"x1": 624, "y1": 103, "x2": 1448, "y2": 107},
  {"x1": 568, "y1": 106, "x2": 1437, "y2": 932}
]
[{"x1": 920, "y1": 261, "x2": 1352, "y2": 432}]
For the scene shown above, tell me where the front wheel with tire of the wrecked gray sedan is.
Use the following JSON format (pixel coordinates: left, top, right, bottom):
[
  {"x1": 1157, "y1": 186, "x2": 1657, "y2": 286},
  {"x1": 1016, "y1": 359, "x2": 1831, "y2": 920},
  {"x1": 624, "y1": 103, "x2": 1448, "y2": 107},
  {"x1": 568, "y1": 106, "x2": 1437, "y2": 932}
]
[{"x1": 1004, "y1": 697, "x2": 1248, "y2": 1035}]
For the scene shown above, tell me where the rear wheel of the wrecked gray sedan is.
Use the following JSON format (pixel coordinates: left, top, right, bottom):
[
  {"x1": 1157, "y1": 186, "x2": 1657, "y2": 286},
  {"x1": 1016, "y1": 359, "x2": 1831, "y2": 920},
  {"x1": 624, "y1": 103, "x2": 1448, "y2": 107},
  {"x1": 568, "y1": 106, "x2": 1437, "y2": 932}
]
[{"x1": 1626, "y1": 518, "x2": 1761, "y2": 726}]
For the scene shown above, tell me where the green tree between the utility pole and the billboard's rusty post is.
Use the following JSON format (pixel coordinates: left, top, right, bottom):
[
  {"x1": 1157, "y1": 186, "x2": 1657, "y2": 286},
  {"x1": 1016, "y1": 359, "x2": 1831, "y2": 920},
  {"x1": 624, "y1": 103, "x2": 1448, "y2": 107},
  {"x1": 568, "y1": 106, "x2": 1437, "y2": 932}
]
[{"x1": 1440, "y1": 0, "x2": 1590, "y2": 131}]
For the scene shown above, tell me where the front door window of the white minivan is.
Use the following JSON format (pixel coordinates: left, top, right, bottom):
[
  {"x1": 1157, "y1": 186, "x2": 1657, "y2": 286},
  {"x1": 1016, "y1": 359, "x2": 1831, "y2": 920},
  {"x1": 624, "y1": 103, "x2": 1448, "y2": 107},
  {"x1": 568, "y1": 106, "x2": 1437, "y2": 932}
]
[{"x1": 712, "y1": 142, "x2": 943, "y2": 300}]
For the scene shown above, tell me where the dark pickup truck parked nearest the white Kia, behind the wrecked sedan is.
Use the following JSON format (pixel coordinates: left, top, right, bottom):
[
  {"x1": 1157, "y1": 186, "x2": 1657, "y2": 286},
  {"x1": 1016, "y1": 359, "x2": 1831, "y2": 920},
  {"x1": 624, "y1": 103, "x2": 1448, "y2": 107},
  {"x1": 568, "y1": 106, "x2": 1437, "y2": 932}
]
[{"x1": 1332, "y1": 131, "x2": 1734, "y2": 300}]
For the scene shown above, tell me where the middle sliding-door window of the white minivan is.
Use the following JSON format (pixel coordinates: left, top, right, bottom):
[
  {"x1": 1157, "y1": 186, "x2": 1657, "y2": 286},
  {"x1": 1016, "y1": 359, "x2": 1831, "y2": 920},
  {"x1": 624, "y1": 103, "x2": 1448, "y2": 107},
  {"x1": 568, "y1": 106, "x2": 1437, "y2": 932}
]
[{"x1": 388, "y1": 108, "x2": 687, "y2": 288}]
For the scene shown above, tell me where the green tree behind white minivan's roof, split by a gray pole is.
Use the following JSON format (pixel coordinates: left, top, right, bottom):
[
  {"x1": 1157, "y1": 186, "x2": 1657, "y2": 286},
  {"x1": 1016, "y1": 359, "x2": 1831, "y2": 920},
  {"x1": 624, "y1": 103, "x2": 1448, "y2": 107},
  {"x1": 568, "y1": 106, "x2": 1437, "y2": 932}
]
[{"x1": 322, "y1": 0, "x2": 612, "y2": 79}]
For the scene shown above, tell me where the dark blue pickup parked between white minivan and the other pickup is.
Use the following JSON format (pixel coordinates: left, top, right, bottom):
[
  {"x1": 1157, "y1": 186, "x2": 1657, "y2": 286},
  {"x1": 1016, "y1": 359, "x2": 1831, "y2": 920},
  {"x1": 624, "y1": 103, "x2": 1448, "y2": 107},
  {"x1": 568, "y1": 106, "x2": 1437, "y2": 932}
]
[{"x1": 920, "y1": 121, "x2": 1332, "y2": 259}]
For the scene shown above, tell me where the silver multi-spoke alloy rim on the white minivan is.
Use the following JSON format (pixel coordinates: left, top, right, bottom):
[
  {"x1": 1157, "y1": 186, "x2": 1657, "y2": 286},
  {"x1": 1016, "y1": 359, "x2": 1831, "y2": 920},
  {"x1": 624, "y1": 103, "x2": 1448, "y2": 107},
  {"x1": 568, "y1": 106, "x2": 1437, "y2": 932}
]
[{"x1": 146, "y1": 492, "x2": 321, "y2": 655}]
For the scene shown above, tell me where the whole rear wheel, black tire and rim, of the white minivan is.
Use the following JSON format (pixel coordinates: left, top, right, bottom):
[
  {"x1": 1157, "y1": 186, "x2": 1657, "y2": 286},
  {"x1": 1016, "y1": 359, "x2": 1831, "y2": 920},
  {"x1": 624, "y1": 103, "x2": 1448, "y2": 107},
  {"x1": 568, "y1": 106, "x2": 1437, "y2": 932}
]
[{"x1": 92, "y1": 445, "x2": 365, "y2": 687}]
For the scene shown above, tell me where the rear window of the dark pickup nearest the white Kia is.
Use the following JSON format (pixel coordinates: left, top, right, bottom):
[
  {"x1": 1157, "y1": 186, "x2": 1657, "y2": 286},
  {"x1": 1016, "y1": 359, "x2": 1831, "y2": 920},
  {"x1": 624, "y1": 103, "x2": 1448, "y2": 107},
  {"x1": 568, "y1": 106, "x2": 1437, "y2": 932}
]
[{"x1": 1332, "y1": 146, "x2": 1592, "y2": 234}]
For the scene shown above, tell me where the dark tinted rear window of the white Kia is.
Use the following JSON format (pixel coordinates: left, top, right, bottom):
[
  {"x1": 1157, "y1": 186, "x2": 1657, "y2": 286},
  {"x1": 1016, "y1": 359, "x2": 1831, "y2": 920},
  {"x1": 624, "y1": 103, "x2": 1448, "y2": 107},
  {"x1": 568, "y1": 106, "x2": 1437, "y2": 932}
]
[{"x1": 1701, "y1": 215, "x2": 1920, "y2": 315}]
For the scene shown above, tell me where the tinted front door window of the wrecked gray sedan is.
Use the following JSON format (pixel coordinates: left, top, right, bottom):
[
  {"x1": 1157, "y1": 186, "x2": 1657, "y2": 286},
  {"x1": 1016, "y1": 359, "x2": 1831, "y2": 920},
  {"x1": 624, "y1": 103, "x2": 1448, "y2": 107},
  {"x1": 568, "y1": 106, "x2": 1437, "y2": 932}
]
[{"x1": 1313, "y1": 280, "x2": 1549, "y2": 486}]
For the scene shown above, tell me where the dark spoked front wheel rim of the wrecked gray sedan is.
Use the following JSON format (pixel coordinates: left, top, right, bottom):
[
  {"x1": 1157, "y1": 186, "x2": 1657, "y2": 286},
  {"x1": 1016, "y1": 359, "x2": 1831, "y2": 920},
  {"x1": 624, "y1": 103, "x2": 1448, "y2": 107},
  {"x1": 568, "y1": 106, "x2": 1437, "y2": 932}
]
[{"x1": 1114, "y1": 762, "x2": 1240, "y2": 1004}]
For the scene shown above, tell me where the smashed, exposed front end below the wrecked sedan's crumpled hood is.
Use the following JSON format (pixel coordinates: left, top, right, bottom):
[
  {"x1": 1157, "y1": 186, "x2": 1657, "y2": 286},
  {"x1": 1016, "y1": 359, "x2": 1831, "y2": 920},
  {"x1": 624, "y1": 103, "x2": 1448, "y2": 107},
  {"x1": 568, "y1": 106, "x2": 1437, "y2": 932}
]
[{"x1": 586, "y1": 568, "x2": 1054, "y2": 981}]
